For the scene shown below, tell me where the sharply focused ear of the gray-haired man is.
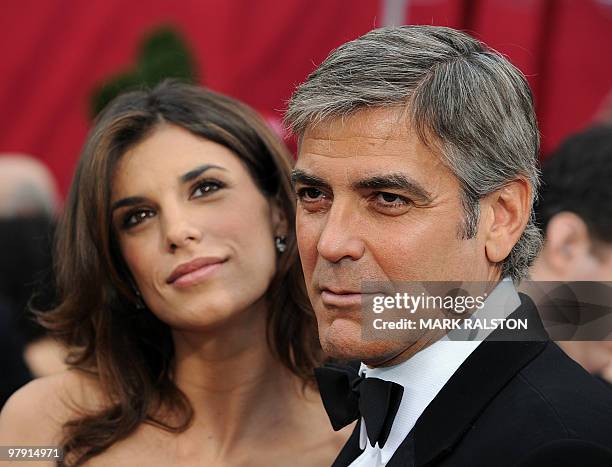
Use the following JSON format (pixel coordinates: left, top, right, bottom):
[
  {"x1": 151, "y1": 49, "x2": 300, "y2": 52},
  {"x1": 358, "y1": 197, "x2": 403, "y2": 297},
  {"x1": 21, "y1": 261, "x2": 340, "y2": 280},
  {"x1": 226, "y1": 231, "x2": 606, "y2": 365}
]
[{"x1": 483, "y1": 179, "x2": 532, "y2": 263}]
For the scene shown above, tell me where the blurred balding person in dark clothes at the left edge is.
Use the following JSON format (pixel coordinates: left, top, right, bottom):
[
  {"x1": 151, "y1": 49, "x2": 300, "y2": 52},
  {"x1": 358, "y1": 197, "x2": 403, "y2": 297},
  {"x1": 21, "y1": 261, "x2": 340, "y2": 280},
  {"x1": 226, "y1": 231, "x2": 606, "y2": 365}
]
[{"x1": 0, "y1": 154, "x2": 64, "y2": 405}]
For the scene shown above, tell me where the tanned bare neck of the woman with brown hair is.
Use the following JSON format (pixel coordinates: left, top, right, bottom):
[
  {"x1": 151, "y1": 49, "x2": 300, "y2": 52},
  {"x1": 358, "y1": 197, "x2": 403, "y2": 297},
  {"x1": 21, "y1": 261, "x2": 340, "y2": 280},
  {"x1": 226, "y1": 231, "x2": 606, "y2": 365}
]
[{"x1": 173, "y1": 305, "x2": 308, "y2": 456}]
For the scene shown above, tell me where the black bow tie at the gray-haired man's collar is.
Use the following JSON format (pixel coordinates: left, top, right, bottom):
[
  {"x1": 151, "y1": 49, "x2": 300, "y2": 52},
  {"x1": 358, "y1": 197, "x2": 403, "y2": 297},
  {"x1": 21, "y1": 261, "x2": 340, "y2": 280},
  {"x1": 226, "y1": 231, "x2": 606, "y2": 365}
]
[{"x1": 315, "y1": 364, "x2": 404, "y2": 448}]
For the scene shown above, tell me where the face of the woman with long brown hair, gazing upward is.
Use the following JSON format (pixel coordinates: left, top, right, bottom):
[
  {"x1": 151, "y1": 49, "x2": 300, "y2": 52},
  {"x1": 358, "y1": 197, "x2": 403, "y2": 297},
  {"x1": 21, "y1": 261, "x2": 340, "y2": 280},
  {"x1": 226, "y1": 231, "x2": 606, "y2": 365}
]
[{"x1": 111, "y1": 125, "x2": 286, "y2": 330}]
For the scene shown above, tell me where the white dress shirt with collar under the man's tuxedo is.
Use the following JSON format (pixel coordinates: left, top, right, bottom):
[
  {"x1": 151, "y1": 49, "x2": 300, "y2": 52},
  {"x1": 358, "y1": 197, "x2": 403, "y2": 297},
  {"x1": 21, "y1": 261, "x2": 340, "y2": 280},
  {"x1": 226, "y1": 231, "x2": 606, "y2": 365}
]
[{"x1": 350, "y1": 278, "x2": 521, "y2": 467}]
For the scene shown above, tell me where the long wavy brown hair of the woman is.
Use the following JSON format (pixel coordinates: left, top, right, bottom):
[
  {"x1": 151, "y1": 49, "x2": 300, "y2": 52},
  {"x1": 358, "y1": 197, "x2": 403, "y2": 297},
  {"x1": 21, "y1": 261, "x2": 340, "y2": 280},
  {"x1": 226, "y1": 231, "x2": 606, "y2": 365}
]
[{"x1": 39, "y1": 81, "x2": 321, "y2": 465}]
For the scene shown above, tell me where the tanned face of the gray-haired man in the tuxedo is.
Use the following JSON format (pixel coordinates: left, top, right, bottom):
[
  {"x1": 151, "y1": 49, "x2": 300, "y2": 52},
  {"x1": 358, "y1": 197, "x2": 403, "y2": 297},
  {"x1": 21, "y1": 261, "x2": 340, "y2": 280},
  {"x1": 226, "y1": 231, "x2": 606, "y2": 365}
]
[{"x1": 293, "y1": 109, "x2": 491, "y2": 365}]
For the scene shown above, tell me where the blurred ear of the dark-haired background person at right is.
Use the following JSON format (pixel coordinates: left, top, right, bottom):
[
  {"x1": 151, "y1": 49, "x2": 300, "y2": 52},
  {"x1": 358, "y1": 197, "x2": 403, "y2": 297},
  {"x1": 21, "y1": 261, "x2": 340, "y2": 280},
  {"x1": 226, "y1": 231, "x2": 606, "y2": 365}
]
[{"x1": 542, "y1": 211, "x2": 590, "y2": 275}]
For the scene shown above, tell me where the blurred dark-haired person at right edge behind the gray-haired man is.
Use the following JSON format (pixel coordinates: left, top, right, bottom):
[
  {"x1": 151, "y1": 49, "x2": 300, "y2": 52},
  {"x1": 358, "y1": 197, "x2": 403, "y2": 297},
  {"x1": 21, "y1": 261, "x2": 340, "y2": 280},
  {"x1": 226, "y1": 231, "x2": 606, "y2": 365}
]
[{"x1": 531, "y1": 126, "x2": 612, "y2": 381}]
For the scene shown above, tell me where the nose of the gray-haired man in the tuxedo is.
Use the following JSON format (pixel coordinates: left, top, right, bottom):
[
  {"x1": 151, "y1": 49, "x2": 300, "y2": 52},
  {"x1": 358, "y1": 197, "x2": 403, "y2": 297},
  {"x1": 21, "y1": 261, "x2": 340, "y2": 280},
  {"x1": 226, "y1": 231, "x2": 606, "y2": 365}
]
[{"x1": 317, "y1": 204, "x2": 365, "y2": 263}]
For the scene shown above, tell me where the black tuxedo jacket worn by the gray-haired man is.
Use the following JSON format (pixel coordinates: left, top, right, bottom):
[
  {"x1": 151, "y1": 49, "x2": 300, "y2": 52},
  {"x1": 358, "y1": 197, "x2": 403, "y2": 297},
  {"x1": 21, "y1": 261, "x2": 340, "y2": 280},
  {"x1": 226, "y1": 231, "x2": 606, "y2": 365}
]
[{"x1": 333, "y1": 294, "x2": 612, "y2": 467}]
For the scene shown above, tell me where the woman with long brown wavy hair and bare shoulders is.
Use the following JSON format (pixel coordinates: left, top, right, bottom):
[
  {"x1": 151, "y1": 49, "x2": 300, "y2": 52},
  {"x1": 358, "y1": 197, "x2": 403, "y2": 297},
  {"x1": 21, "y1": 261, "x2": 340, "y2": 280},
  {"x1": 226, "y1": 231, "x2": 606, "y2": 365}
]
[{"x1": 0, "y1": 82, "x2": 347, "y2": 466}]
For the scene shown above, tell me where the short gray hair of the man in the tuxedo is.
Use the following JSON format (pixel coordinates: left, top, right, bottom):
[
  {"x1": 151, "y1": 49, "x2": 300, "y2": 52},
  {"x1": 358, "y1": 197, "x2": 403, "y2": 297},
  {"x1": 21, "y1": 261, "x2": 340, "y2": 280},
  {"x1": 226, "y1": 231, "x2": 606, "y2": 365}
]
[{"x1": 285, "y1": 26, "x2": 542, "y2": 283}]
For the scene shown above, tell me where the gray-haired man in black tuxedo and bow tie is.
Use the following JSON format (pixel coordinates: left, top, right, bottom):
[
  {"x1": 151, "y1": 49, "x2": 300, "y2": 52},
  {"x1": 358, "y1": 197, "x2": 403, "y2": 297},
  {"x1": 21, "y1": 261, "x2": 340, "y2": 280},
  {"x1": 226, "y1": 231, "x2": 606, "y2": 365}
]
[{"x1": 286, "y1": 26, "x2": 612, "y2": 467}]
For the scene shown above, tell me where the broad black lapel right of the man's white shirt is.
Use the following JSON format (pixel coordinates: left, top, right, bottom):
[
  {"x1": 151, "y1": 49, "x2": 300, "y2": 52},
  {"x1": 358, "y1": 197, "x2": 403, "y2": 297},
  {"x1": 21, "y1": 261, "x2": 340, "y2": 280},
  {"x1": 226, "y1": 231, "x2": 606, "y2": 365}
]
[{"x1": 408, "y1": 294, "x2": 547, "y2": 466}]
